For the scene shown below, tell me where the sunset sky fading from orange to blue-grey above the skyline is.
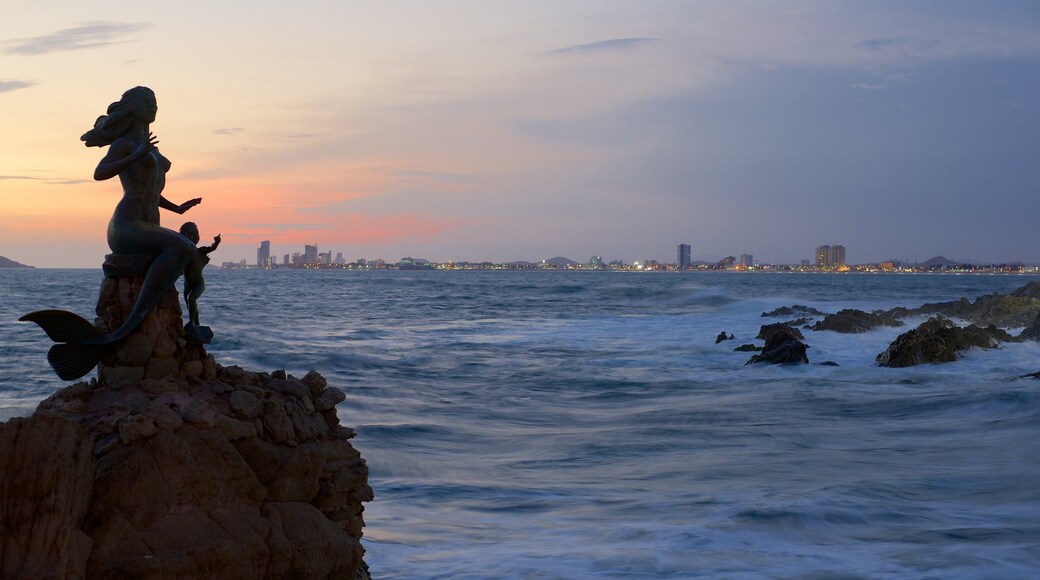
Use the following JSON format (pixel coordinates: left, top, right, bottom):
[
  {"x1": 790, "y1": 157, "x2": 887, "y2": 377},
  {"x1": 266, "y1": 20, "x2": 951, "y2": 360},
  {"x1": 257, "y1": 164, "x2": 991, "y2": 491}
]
[{"x1": 0, "y1": 0, "x2": 1040, "y2": 267}]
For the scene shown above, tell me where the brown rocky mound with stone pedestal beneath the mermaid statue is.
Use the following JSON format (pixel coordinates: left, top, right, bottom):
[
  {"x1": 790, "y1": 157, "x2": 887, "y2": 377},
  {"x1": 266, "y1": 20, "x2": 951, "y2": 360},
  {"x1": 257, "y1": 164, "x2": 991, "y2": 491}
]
[{"x1": 0, "y1": 279, "x2": 372, "y2": 579}]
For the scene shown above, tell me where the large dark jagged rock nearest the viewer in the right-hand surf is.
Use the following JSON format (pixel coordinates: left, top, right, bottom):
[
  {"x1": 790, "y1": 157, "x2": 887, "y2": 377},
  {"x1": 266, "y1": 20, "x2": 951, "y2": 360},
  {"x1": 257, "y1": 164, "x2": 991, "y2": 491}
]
[{"x1": 876, "y1": 316, "x2": 1014, "y2": 367}]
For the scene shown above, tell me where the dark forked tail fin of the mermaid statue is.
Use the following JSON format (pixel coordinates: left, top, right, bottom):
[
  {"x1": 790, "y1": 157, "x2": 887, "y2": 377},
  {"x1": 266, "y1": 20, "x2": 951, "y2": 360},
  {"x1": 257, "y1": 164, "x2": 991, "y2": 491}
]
[{"x1": 19, "y1": 310, "x2": 116, "y2": 380}]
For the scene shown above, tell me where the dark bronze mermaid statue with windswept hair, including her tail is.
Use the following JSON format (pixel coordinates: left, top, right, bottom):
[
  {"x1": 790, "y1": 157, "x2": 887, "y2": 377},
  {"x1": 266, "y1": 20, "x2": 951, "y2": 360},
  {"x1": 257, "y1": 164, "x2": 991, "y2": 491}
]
[{"x1": 20, "y1": 86, "x2": 202, "y2": 380}]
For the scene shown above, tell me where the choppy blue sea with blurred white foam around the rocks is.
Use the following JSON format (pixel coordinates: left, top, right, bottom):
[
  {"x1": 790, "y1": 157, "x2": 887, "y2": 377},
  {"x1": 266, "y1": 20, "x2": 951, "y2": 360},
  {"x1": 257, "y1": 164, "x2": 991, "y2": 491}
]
[{"x1": 0, "y1": 269, "x2": 1040, "y2": 579}]
